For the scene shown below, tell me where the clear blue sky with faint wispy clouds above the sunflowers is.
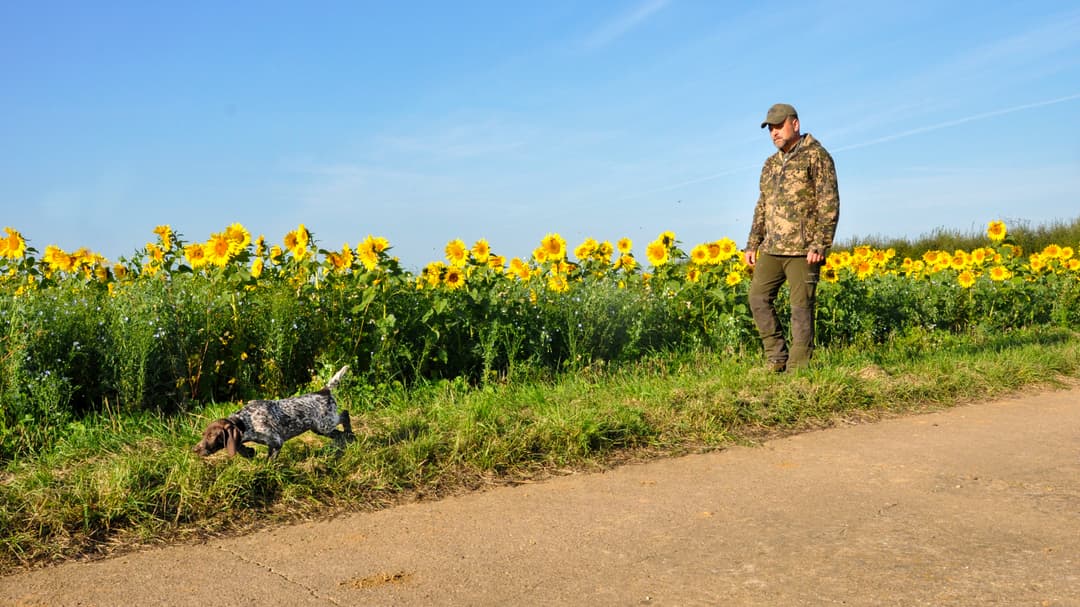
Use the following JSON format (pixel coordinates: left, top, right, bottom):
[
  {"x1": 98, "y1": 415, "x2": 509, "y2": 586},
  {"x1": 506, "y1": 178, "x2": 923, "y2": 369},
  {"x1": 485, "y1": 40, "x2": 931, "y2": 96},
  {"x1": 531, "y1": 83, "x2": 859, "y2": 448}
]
[{"x1": 0, "y1": 0, "x2": 1080, "y2": 269}]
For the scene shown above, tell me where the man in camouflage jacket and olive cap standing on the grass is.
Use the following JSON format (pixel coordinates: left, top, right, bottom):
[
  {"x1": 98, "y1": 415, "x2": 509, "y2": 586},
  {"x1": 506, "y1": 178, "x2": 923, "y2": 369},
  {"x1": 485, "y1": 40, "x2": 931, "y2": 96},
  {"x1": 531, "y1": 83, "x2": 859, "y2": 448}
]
[{"x1": 744, "y1": 104, "x2": 840, "y2": 373}]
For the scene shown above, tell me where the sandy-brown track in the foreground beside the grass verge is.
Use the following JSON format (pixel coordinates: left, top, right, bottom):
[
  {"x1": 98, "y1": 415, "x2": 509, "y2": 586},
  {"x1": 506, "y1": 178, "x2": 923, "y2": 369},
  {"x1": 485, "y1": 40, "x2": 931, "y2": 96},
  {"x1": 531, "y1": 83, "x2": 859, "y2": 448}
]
[{"x1": 0, "y1": 389, "x2": 1080, "y2": 607}]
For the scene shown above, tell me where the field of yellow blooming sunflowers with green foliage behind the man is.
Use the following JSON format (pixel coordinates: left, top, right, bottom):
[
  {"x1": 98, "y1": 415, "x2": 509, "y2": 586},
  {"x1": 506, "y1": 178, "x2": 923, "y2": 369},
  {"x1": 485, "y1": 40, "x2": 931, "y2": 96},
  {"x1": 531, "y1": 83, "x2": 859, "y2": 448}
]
[{"x1": 0, "y1": 220, "x2": 1080, "y2": 459}]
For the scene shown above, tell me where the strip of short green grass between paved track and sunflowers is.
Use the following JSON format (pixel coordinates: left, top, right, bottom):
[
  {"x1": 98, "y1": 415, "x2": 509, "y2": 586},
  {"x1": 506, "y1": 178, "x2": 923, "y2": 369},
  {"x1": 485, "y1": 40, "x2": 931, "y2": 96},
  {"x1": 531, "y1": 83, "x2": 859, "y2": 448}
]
[{"x1": 0, "y1": 327, "x2": 1080, "y2": 571}]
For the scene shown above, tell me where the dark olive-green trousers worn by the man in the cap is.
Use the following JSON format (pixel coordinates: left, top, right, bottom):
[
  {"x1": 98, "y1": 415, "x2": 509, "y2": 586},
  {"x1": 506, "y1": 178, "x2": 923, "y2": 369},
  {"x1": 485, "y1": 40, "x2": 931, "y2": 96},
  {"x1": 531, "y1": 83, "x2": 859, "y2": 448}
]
[{"x1": 750, "y1": 253, "x2": 821, "y2": 368}]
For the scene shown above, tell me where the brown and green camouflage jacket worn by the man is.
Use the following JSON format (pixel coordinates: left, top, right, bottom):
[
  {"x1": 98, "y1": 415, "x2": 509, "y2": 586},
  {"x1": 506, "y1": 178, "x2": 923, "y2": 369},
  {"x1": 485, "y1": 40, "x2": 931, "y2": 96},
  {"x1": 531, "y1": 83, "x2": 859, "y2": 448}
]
[{"x1": 746, "y1": 134, "x2": 840, "y2": 255}]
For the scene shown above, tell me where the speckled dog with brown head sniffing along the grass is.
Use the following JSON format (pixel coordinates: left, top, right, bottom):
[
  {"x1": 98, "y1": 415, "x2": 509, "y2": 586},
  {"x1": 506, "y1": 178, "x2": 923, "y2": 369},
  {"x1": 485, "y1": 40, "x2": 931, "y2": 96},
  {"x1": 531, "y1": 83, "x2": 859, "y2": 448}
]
[{"x1": 194, "y1": 366, "x2": 353, "y2": 459}]
